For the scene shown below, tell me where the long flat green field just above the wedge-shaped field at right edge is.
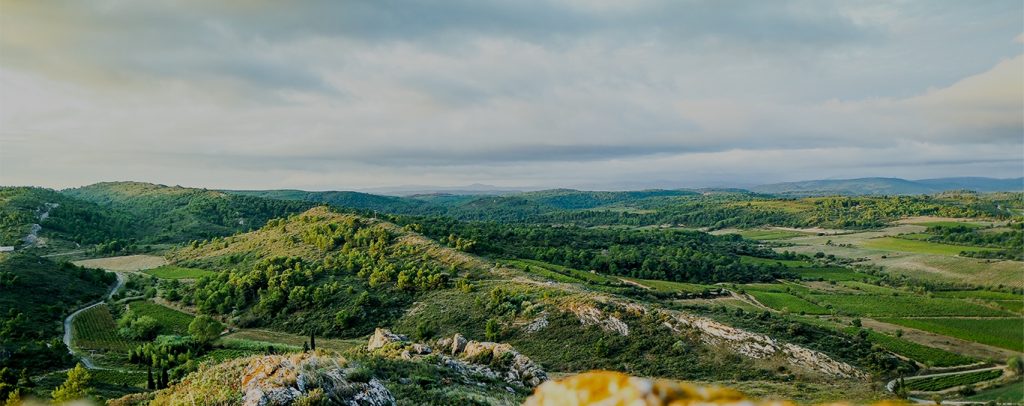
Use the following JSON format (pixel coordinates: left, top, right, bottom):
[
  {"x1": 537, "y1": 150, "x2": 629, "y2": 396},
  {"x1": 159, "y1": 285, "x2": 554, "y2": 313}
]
[{"x1": 812, "y1": 293, "x2": 1012, "y2": 317}]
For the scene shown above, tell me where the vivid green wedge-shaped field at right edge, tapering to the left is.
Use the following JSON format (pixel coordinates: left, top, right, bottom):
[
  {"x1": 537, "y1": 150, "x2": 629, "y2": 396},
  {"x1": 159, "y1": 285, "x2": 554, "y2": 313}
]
[{"x1": 882, "y1": 318, "x2": 1024, "y2": 352}]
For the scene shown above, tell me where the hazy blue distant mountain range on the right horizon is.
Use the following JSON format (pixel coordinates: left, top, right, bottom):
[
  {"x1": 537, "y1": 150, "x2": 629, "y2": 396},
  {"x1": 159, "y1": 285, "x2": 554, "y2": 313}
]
[{"x1": 750, "y1": 177, "x2": 1024, "y2": 196}]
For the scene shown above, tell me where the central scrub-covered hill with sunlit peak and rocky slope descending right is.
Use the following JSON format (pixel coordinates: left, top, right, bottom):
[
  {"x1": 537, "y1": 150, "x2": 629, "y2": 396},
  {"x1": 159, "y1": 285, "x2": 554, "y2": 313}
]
[{"x1": 160, "y1": 207, "x2": 892, "y2": 387}]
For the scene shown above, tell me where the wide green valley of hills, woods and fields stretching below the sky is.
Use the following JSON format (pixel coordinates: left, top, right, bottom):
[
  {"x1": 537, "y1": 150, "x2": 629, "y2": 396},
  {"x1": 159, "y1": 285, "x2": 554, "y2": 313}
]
[{"x1": 0, "y1": 182, "x2": 1024, "y2": 405}]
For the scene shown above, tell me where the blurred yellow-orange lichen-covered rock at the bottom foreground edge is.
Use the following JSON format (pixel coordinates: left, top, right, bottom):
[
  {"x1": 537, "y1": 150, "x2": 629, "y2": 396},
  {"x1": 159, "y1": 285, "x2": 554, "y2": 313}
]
[{"x1": 524, "y1": 371, "x2": 791, "y2": 406}]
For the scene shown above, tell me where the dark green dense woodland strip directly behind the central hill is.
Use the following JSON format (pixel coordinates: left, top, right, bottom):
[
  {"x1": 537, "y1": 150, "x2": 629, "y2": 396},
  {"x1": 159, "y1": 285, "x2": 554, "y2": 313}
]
[{"x1": 395, "y1": 217, "x2": 788, "y2": 283}]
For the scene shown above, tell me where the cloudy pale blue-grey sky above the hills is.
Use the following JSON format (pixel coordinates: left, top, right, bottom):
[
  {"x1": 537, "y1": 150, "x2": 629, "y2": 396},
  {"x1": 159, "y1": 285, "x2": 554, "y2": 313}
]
[{"x1": 0, "y1": 0, "x2": 1024, "y2": 190}]
